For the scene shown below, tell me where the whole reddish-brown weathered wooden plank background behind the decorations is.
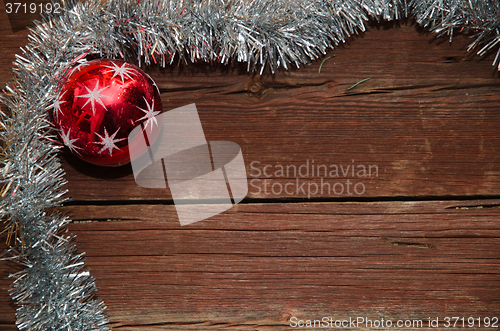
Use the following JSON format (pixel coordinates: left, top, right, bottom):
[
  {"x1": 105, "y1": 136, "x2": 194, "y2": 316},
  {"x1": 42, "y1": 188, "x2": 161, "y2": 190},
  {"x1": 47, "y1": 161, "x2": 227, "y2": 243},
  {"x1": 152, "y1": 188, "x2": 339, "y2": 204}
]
[{"x1": 0, "y1": 3, "x2": 500, "y2": 330}]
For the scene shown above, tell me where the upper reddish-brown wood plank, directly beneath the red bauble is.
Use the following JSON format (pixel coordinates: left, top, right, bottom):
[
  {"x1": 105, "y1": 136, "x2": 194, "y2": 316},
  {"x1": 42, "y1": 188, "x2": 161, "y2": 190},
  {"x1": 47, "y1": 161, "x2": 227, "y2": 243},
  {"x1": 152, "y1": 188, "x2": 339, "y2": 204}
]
[{"x1": 57, "y1": 24, "x2": 500, "y2": 201}]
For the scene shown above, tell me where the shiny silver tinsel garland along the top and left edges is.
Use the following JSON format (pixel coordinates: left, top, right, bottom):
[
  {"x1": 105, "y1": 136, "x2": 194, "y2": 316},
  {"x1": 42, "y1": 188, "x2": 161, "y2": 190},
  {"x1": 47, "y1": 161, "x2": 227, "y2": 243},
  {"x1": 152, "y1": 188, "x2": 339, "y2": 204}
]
[{"x1": 0, "y1": 0, "x2": 500, "y2": 331}]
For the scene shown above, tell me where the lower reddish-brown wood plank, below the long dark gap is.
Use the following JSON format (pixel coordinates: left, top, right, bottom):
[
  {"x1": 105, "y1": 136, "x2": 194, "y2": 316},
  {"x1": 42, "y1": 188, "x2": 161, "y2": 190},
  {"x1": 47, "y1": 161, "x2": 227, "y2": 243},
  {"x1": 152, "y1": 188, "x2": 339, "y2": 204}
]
[{"x1": 0, "y1": 200, "x2": 500, "y2": 330}]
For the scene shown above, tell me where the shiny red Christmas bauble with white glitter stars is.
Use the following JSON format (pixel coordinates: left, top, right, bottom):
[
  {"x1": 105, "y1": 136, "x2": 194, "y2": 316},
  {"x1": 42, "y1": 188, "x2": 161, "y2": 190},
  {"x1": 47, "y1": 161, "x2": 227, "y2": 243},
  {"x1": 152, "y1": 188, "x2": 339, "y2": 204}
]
[{"x1": 53, "y1": 59, "x2": 162, "y2": 167}]
